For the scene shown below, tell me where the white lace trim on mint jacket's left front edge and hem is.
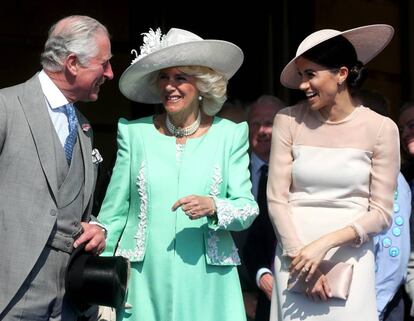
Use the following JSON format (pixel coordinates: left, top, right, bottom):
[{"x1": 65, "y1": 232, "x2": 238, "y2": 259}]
[{"x1": 115, "y1": 162, "x2": 148, "y2": 261}]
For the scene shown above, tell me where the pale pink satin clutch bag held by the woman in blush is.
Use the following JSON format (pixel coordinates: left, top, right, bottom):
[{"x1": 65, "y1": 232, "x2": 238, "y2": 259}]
[{"x1": 287, "y1": 260, "x2": 354, "y2": 300}]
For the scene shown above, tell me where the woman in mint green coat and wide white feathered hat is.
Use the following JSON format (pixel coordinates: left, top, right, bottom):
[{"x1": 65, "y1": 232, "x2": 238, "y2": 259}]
[{"x1": 99, "y1": 28, "x2": 258, "y2": 321}]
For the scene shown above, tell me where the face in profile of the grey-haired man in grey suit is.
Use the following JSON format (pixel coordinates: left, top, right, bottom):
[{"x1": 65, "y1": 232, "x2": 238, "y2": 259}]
[{"x1": 74, "y1": 33, "x2": 114, "y2": 101}]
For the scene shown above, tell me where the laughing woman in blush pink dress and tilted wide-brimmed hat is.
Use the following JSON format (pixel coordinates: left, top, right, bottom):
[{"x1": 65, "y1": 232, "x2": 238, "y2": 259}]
[{"x1": 267, "y1": 25, "x2": 400, "y2": 321}]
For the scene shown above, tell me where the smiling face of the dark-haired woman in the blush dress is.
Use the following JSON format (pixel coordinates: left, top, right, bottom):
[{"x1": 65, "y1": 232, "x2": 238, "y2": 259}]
[{"x1": 296, "y1": 57, "x2": 343, "y2": 110}]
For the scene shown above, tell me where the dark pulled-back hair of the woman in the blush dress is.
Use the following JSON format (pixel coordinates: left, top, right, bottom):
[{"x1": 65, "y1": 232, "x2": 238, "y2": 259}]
[{"x1": 302, "y1": 35, "x2": 368, "y2": 91}]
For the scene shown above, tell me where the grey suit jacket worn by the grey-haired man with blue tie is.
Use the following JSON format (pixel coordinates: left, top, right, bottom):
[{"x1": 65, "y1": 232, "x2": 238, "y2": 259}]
[{"x1": 0, "y1": 75, "x2": 96, "y2": 314}]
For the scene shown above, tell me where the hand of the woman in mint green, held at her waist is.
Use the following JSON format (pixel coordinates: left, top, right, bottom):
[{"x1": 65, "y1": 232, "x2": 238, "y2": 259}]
[{"x1": 172, "y1": 195, "x2": 216, "y2": 220}]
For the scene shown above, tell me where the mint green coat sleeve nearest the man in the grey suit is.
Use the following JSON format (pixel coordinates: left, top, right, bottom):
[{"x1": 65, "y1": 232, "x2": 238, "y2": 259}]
[{"x1": 99, "y1": 119, "x2": 131, "y2": 256}]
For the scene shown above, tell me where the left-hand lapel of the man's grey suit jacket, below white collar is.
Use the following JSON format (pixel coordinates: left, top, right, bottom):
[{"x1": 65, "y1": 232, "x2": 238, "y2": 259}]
[{"x1": 19, "y1": 74, "x2": 57, "y2": 200}]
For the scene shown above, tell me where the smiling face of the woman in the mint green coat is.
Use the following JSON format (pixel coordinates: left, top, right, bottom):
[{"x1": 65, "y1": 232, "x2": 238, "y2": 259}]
[{"x1": 157, "y1": 67, "x2": 199, "y2": 115}]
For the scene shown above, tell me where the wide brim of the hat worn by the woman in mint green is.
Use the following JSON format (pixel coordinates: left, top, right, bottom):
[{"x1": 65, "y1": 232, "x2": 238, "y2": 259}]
[{"x1": 119, "y1": 40, "x2": 244, "y2": 104}]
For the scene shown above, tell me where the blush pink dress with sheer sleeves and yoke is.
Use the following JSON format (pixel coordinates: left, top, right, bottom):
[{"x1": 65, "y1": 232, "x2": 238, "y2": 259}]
[{"x1": 267, "y1": 103, "x2": 400, "y2": 321}]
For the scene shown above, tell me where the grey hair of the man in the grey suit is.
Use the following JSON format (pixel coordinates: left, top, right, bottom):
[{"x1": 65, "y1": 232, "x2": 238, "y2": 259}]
[{"x1": 40, "y1": 15, "x2": 109, "y2": 72}]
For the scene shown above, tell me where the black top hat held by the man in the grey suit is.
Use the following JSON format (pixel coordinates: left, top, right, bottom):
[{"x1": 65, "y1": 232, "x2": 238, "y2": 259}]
[{"x1": 65, "y1": 244, "x2": 130, "y2": 314}]
